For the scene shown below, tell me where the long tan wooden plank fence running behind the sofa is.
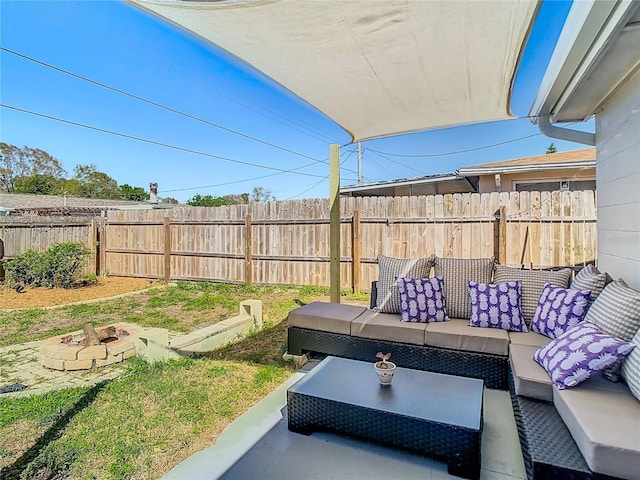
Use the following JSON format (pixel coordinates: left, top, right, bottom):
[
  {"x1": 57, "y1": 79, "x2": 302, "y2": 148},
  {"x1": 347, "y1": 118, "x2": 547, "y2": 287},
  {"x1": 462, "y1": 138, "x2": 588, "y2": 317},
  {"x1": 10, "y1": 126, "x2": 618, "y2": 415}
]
[{"x1": 0, "y1": 191, "x2": 597, "y2": 291}]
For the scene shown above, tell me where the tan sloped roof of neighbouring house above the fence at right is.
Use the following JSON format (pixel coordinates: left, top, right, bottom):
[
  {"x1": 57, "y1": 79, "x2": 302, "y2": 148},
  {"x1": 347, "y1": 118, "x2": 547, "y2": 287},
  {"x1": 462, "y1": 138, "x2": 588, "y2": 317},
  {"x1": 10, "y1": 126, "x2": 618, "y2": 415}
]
[{"x1": 458, "y1": 148, "x2": 596, "y2": 177}]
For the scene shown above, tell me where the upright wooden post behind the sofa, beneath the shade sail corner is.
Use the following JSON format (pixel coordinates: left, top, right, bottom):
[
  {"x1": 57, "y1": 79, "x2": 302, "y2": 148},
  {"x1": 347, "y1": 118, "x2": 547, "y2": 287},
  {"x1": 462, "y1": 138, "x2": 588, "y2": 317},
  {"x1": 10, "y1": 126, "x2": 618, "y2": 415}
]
[{"x1": 329, "y1": 144, "x2": 340, "y2": 303}]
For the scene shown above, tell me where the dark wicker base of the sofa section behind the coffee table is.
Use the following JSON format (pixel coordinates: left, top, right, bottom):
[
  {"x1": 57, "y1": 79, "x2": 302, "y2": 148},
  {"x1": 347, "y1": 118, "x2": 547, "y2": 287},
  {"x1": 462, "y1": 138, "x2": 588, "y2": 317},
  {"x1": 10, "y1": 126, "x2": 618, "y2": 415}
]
[{"x1": 287, "y1": 327, "x2": 508, "y2": 390}]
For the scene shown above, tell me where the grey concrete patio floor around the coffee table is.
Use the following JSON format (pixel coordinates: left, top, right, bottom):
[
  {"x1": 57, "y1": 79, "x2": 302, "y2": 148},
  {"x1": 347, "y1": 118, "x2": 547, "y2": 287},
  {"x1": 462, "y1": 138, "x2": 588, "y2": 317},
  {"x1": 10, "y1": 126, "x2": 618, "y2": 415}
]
[{"x1": 162, "y1": 362, "x2": 526, "y2": 480}]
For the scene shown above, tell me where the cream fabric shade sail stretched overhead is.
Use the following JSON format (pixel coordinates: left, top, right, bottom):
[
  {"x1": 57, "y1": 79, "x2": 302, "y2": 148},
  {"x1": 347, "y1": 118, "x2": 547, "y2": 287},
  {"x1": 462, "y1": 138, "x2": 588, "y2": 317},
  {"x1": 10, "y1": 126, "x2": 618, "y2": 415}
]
[{"x1": 131, "y1": 0, "x2": 538, "y2": 140}]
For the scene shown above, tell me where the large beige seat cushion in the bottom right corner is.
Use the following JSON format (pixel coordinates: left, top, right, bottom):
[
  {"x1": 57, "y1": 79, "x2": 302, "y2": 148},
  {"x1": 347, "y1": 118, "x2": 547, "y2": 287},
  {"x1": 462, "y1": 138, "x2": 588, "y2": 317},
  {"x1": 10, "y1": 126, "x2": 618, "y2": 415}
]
[{"x1": 553, "y1": 375, "x2": 640, "y2": 479}]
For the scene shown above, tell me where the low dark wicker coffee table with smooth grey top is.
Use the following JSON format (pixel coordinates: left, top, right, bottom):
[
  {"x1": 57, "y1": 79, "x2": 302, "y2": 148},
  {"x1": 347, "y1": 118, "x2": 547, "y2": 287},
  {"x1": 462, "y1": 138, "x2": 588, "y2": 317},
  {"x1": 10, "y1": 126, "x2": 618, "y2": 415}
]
[{"x1": 287, "y1": 357, "x2": 483, "y2": 479}]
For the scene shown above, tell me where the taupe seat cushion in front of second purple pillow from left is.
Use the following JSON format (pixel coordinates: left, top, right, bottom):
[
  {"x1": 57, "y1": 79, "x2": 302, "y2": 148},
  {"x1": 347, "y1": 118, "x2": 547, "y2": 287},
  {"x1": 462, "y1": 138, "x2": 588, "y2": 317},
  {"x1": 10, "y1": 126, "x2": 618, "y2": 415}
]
[{"x1": 425, "y1": 318, "x2": 509, "y2": 357}]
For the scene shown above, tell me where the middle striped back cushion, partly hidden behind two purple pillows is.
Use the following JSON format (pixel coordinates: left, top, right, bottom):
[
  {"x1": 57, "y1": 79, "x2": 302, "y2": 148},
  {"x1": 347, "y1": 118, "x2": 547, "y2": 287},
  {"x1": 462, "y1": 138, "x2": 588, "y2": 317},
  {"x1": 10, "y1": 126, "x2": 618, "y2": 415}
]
[{"x1": 433, "y1": 255, "x2": 494, "y2": 318}]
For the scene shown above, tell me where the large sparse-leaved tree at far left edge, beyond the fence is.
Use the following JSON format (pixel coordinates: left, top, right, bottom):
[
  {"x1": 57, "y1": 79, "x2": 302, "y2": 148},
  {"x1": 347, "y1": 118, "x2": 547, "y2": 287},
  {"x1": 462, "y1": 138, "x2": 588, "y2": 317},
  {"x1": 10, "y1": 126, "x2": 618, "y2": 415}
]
[{"x1": 0, "y1": 142, "x2": 67, "y2": 192}]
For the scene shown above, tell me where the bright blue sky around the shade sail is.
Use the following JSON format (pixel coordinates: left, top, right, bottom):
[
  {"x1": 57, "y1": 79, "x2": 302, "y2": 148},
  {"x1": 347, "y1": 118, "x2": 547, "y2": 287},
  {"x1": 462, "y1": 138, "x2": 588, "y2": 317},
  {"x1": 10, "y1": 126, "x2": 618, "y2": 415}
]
[{"x1": 0, "y1": 0, "x2": 585, "y2": 201}]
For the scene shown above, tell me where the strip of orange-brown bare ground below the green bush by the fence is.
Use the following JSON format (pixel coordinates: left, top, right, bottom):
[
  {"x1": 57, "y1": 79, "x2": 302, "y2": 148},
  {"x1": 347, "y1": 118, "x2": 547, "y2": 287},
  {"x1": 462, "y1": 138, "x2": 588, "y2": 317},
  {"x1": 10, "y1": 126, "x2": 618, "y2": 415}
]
[{"x1": 0, "y1": 277, "x2": 152, "y2": 309}]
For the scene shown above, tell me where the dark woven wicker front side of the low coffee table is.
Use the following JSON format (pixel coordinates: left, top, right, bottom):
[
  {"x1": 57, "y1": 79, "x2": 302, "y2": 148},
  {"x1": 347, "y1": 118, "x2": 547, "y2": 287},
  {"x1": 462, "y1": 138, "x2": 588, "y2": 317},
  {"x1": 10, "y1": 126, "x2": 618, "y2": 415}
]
[{"x1": 287, "y1": 391, "x2": 482, "y2": 479}]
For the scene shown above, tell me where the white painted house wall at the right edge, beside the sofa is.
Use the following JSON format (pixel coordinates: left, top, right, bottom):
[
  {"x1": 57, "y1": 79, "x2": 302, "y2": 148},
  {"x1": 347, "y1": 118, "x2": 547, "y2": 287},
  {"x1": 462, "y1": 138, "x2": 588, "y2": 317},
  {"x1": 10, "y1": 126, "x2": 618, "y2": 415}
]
[{"x1": 596, "y1": 73, "x2": 640, "y2": 289}]
